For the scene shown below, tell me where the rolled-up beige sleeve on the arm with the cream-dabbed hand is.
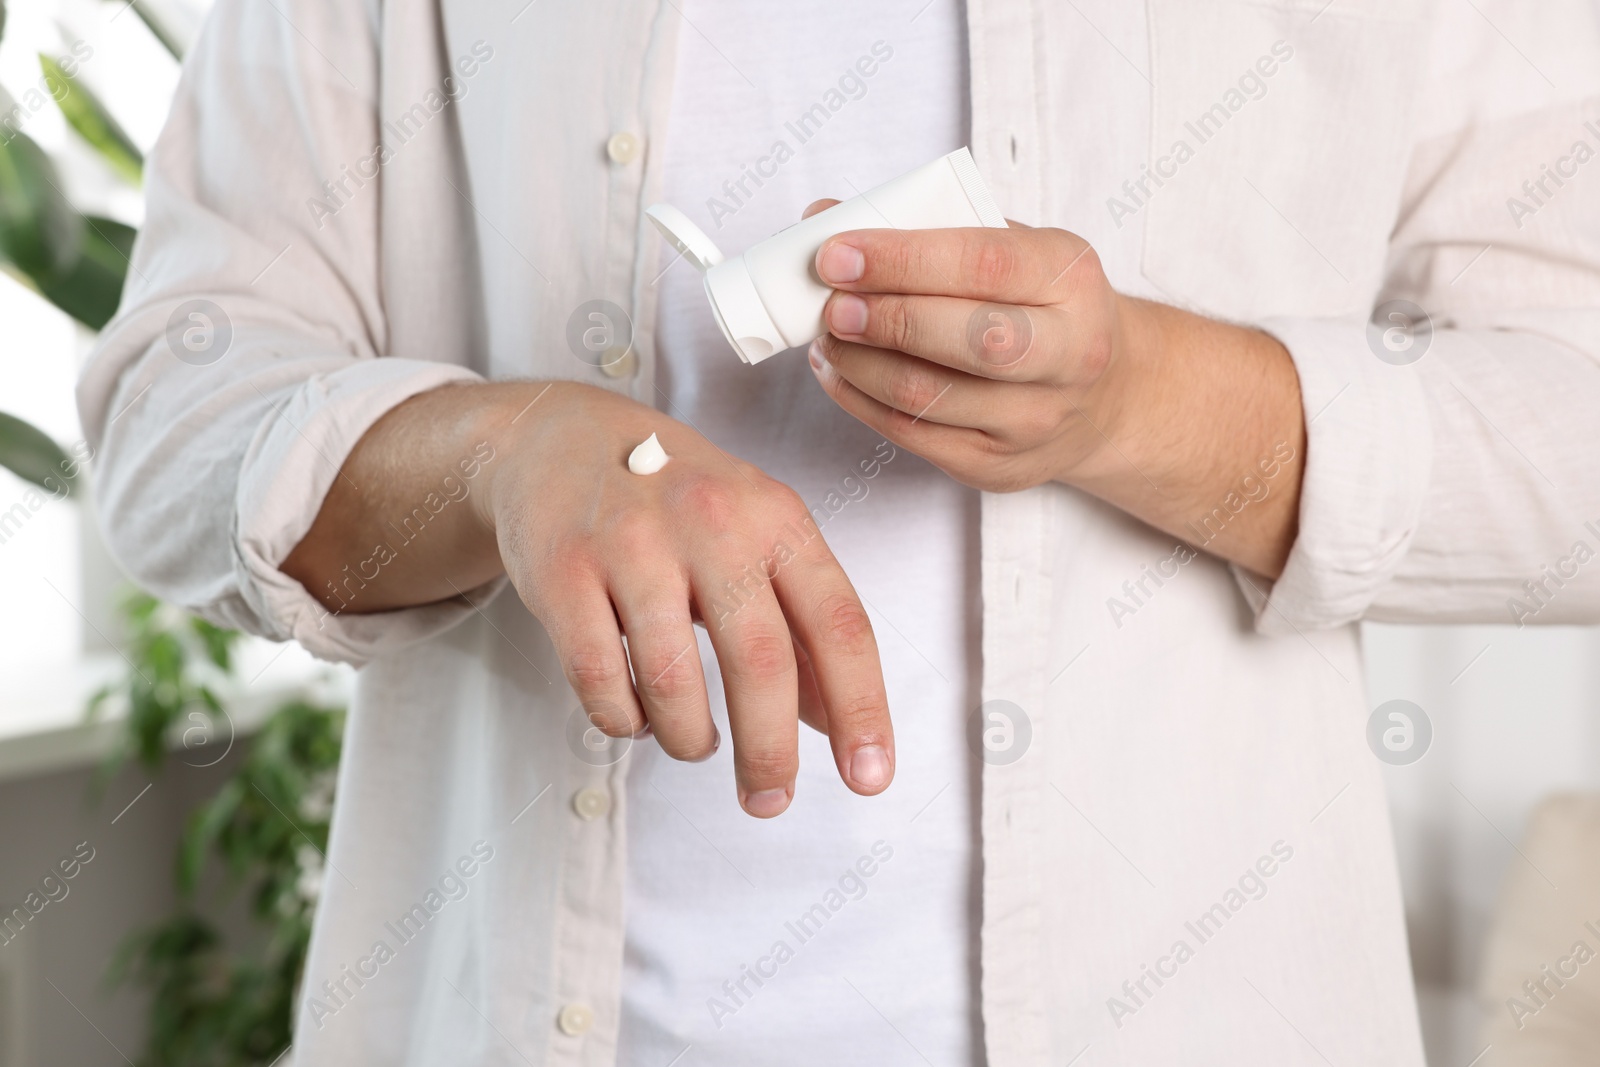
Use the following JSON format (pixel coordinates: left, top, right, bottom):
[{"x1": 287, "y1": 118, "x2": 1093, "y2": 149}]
[{"x1": 78, "y1": 0, "x2": 478, "y2": 664}]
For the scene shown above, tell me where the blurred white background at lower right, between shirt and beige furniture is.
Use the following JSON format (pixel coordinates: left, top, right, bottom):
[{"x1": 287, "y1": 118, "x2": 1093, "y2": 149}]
[{"x1": 1363, "y1": 624, "x2": 1600, "y2": 1067}]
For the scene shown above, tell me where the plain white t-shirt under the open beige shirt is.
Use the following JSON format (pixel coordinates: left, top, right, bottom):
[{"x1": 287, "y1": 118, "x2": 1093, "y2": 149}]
[{"x1": 618, "y1": 0, "x2": 982, "y2": 1067}]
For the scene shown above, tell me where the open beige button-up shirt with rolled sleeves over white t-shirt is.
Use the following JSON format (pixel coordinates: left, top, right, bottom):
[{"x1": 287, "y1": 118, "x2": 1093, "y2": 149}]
[{"x1": 80, "y1": 0, "x2": 1600, "y2": 1067}]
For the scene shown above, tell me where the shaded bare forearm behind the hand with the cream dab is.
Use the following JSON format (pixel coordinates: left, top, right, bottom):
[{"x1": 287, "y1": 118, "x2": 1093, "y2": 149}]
[{"x1": 282, "y1": 382, "x2": 550, "y2": 614}]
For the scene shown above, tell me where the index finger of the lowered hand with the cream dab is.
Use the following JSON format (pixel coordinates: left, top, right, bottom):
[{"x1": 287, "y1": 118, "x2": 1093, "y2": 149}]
[{"x1": 773, "y1": 533, "x2": 894, "y2": 797}]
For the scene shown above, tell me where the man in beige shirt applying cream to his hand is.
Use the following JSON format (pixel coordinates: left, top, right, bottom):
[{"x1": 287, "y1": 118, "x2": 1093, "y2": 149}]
[{"x1": 82, "y1": 0, "x2": 1600, "y2": 1067}]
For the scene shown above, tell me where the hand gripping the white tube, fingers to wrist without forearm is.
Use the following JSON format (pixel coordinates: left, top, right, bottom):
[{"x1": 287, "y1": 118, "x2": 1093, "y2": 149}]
[{"x1": 810, "y1": 224, "x2": 1136, "y2": 493}]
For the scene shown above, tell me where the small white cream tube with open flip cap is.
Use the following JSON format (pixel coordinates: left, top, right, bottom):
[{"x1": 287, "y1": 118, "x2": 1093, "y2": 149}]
[{"x1": 646, "y1": 149, "x2": 1005, "y2": 363}]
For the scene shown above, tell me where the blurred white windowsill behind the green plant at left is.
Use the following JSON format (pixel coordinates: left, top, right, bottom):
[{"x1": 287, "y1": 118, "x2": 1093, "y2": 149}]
[{"x1": 0, "y1": 638, "x2": 352, "y2": 782}]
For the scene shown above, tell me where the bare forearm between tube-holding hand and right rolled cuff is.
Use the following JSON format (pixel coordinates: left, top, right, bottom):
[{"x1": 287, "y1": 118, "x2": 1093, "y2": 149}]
[{"x1": 1070, "y1": 298, "x2": 1306, "y2": 577}]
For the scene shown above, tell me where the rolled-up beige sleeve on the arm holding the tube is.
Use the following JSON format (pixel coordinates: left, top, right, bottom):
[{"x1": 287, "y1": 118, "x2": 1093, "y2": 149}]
[{"x1": 1238, "y1": 0, "x2": 1600, "y2": 633}]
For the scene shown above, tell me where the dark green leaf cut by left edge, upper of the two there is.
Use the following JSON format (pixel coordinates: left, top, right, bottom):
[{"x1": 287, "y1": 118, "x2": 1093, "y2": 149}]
[{"x1": 0, "y1": 133, "x2": 85, "y2": 285}]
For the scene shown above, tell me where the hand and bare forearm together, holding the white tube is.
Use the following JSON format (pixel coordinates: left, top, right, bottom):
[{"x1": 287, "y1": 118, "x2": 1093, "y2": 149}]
[{"x1": 806, "y1": 202, "x2": 1306, "y2": 577}]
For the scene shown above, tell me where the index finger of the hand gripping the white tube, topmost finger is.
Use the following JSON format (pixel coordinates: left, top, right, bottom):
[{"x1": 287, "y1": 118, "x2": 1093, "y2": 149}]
[{"x1": 816, "y1": 227, "x2": 1094, "y2": 306}]
